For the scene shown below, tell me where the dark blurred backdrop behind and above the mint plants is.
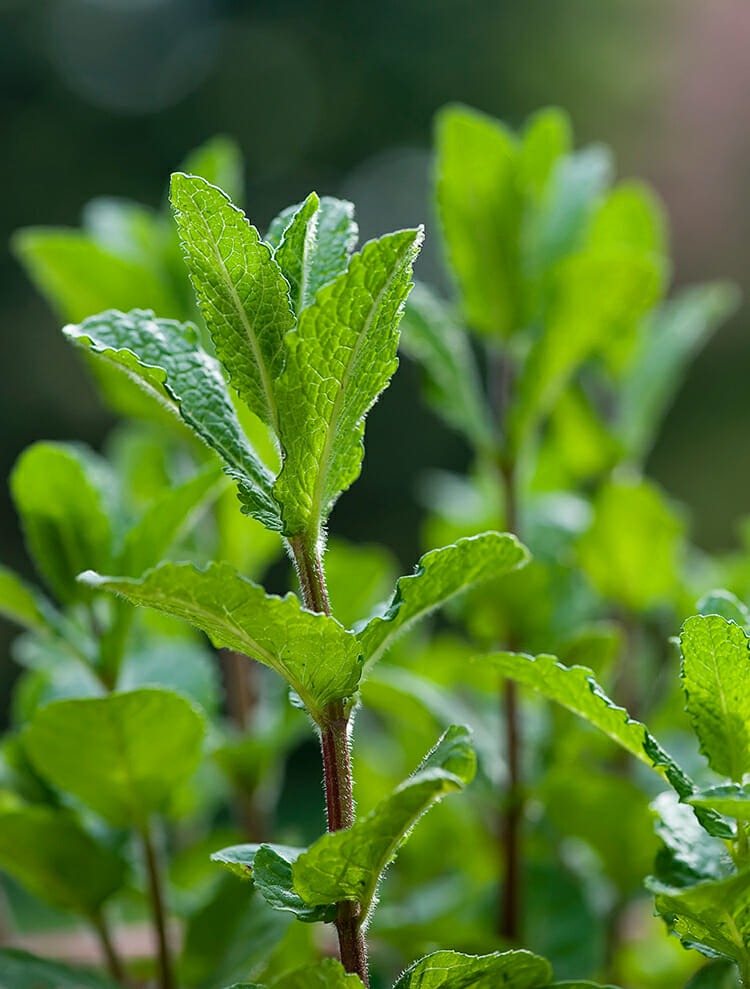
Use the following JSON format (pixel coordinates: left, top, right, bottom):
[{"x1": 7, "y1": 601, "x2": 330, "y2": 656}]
[{"x1": 0, "y1": 0, "x2": 750, "y2": 694}]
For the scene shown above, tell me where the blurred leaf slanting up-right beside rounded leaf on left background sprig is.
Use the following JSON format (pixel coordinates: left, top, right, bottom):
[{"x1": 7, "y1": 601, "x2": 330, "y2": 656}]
[{"x1": 115, "y1": 468, "x2": 221, "y2": 577}]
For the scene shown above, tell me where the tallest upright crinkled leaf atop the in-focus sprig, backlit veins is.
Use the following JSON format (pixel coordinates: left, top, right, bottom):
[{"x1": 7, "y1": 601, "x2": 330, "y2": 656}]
[{"x1": 171, "y1": 172, "x2": 294, "y2": 433}]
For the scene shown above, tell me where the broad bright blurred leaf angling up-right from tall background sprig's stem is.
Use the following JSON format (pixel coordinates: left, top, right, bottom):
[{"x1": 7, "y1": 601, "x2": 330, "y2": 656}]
[{"x1": 508, "y1": 247, "x2": 663, "y2": 450}]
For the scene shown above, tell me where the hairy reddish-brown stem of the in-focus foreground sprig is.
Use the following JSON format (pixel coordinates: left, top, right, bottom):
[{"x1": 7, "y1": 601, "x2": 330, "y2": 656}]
[{"x1": 289, "y1": 533, "x2": 370, "y2": 987}]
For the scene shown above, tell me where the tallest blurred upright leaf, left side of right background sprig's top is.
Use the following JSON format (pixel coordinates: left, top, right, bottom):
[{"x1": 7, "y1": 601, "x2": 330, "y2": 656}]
[{"x1": 436, "y1": 105, "x2": 522, "y2": 338}]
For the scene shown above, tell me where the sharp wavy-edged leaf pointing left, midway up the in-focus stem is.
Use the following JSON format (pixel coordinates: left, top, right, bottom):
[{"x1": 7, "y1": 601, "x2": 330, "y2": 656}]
[{"x1": 83, "y1": 563, "x2": 361, "y2": 722}]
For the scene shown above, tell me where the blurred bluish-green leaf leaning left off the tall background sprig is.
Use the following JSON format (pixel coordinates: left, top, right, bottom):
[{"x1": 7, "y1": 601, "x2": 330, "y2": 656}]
[{"x1": 401, "y1": 283, "x2": 493, "y2": 449}]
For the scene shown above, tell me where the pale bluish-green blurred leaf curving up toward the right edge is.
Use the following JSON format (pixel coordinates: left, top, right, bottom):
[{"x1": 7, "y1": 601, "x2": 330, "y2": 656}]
[{"x1": 616, "y1": 282, "x2": 739, "y2": 458}]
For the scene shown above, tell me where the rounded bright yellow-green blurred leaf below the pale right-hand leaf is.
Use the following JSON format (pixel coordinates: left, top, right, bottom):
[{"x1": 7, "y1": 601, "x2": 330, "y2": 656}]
[{"x1": 578, "y1": 479, "x2": 684, "y2": 611}]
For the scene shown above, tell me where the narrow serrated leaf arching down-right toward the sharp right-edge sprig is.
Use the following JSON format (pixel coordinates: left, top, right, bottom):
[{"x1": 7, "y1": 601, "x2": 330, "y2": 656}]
[{"x1": 481, "y1": 652, "x2": 733, "y2": 838}]
